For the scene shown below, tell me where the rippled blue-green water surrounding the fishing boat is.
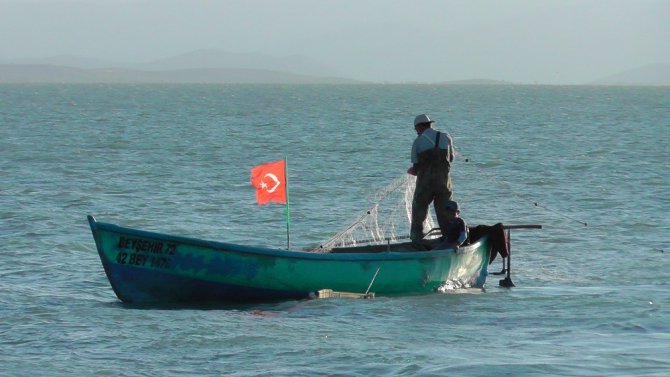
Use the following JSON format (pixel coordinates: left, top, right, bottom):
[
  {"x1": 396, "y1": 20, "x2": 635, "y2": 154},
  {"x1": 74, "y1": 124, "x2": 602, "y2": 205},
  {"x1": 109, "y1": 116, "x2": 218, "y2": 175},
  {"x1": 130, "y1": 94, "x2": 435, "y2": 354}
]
[{"x1": 0, "y1": 85, "x2": 670, "y2": 376}]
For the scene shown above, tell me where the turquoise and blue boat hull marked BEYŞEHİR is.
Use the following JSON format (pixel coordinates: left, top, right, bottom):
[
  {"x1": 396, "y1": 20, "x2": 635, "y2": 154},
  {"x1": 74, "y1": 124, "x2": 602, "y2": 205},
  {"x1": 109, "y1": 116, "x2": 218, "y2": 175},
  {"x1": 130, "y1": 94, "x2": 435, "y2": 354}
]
[{"x1": 88, "y1": 216, "x2": 491, "y2": 303}]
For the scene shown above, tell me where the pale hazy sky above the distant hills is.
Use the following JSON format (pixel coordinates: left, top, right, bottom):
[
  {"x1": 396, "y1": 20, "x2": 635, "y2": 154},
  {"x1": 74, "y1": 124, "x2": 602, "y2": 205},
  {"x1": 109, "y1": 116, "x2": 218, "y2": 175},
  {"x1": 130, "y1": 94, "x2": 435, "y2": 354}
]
[{"x1": 0, "y1": 0, "x2": 670, "y2": 84}]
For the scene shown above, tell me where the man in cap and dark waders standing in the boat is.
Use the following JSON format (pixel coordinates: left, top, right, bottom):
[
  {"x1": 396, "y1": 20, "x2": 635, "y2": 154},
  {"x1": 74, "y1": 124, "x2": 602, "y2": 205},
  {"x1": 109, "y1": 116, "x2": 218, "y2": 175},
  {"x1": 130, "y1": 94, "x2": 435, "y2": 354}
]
[{"x1": 407, "y1": 114, "x2": 454, "y2": 244}]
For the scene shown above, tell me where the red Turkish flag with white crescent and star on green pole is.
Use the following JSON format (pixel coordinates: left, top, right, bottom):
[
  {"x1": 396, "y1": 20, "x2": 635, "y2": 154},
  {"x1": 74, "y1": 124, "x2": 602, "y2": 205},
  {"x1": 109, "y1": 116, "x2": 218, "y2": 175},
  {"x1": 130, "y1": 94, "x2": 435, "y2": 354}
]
[{"x1": 251, "y1": 160, "x2": 286, "y2": 204}]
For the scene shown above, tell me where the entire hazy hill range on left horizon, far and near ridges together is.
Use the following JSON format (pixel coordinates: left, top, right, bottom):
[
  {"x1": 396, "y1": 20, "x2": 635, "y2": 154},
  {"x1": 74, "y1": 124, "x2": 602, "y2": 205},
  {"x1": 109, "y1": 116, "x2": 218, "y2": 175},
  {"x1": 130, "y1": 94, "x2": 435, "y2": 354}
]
[{"x1": 0, "y1": 50, "x2": 361, "y2": 84}]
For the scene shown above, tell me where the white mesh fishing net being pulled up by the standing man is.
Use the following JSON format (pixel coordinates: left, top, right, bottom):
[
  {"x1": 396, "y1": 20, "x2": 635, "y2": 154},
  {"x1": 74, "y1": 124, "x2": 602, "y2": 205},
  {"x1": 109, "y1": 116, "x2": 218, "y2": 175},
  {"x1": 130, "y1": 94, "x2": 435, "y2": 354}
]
[{"x1": 312, "y1": 174, "x2": 434, "y2": 253}]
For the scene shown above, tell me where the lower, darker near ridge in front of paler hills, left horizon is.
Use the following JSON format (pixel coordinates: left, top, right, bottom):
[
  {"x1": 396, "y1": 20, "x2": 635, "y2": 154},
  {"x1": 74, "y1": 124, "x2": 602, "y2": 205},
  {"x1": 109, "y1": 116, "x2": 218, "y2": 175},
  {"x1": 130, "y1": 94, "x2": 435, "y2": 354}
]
[{"x1": 0, "y1": 64, "x2": 360, "y2": 84}]
